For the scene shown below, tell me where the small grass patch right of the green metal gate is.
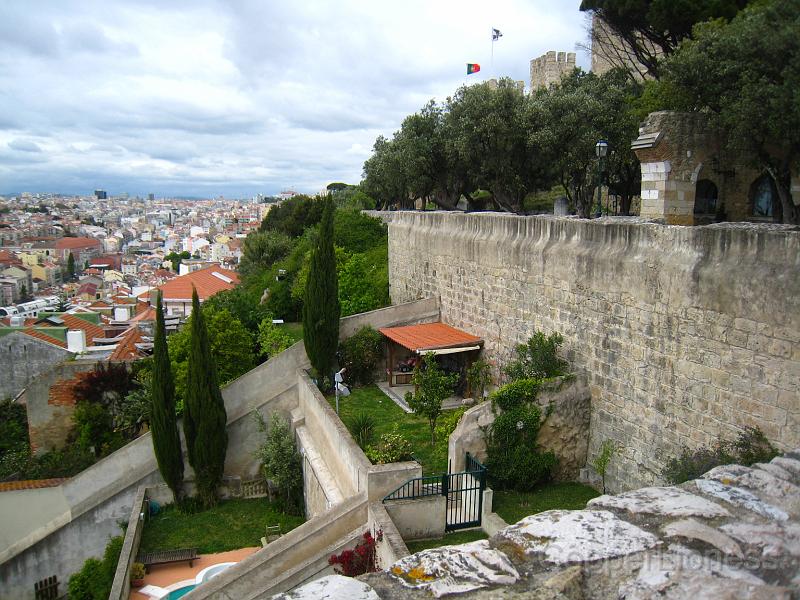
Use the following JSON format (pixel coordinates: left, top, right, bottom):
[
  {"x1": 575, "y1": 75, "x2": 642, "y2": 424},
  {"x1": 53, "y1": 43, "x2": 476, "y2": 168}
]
[{"x1": 492, "y1": 481, "x2": 600, "y2": 524}]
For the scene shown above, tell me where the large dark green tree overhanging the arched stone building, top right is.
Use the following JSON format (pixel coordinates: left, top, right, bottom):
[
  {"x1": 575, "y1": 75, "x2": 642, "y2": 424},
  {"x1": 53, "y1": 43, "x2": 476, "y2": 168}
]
[{"x1": 658, "y1": 0, "x2": 800, "y2": 223}]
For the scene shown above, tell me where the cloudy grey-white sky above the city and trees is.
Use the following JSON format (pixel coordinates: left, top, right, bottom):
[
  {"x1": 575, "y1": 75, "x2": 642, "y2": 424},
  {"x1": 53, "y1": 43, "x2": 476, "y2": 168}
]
[{"x1": 0, "y1": 0, "x2": 589, "y2": 197}]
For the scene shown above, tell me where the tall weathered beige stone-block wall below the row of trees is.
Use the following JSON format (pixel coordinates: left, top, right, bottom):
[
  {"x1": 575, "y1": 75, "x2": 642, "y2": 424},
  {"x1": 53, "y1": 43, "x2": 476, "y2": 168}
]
[{"x1": 373, "y1": 212, "x2": 800, "y2": 491}]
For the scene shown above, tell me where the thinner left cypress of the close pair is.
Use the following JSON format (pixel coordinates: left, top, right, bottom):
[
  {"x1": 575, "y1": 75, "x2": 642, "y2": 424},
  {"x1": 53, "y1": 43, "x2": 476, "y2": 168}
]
[{"x1": 150, "y1": 293, "x2": 183, "y2": 503}]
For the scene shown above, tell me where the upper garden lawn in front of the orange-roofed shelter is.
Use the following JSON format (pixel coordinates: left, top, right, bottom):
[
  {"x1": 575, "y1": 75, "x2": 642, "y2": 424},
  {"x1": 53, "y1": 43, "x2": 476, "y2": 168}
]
[{"x1": 328, "y1": 385, "x2": 454, "y2": 475}]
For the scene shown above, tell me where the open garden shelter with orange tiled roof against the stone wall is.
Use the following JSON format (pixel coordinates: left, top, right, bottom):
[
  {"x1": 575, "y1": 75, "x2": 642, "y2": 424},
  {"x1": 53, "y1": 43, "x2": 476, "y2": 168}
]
[{"x1": 378, "y1": 322, "x2": 483, "y2": 394}]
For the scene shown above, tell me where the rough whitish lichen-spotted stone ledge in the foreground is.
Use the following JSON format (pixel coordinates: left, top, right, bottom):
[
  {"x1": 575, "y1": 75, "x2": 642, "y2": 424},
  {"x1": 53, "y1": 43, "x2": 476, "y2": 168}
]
[{"x1": 280, "y1": 450, "x2": 800, "y2": 600}]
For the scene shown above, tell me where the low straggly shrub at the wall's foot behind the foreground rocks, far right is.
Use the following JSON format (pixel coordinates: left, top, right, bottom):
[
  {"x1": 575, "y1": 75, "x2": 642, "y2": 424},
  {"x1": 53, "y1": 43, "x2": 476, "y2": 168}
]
[{"x1": 661, "y1": 427, "x2": 778, "y2": 485}]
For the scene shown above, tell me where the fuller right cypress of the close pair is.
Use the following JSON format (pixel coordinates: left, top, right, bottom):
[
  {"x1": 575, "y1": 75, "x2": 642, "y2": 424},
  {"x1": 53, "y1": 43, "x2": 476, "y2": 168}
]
[{"x1": 183, "y1": 289, "x2": 228, "y2": 507}]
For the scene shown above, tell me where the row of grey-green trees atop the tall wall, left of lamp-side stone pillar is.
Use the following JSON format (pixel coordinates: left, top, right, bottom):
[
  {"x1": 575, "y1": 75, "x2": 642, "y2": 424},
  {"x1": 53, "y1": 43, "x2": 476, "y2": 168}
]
[{"x1": 364, "y1": 71, "x2": 641, "y2": 216}]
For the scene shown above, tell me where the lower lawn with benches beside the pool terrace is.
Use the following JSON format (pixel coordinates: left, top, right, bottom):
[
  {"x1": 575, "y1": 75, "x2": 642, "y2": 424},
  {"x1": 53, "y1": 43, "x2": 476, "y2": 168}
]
[{"x1": 140, "y1": 498, "x2": 305, "y2": 554}]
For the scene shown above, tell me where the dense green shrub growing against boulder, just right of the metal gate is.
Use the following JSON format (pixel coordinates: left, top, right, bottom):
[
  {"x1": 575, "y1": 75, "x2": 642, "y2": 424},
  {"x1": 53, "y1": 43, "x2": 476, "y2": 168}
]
[{"x1": 486, "y1": 404, "x2": 558, "y2": 492}]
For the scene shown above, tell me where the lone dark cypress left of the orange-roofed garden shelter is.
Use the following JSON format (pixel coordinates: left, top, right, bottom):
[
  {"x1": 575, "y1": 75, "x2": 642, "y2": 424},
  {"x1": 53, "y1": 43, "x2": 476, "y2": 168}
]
[{"x1": 303, "y1": 198, "x2": 341, "y2": 385}]
